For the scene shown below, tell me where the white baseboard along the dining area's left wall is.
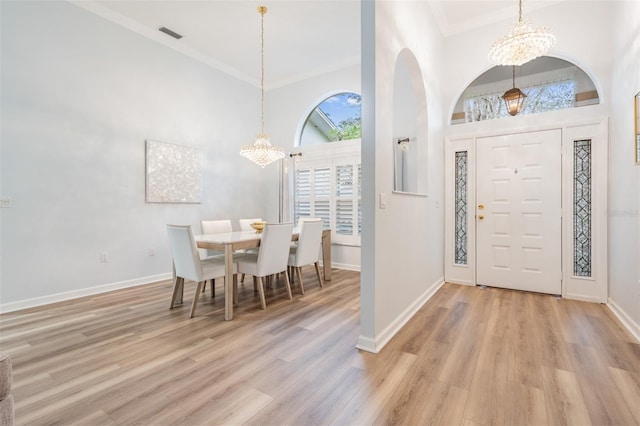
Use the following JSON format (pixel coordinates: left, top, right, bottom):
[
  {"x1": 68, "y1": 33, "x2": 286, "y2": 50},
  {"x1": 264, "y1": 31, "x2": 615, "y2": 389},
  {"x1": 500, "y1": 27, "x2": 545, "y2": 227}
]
[{"x1": 0, "y1": 272, "x2": 172, "y2": 313}]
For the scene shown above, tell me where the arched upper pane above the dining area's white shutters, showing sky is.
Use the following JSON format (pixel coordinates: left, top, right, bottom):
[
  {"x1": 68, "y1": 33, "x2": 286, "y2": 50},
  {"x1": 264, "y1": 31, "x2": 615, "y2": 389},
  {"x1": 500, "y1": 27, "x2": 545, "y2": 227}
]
[{"x1": 300, "y1": 92, "x2": 362, "y2": 146}]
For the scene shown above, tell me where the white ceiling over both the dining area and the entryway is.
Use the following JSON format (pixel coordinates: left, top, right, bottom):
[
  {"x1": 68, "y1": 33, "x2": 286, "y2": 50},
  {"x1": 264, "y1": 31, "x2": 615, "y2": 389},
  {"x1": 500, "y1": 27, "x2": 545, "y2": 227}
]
[{"x1": 70, "y1": 0, "x2": 561, "y2": 88}]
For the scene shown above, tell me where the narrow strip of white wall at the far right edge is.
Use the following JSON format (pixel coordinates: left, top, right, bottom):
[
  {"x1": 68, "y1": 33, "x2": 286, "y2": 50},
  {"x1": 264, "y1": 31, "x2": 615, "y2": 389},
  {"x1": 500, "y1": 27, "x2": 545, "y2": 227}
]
[{"x1": 609, "y1": 1, "x2": 640, "y2": 340}]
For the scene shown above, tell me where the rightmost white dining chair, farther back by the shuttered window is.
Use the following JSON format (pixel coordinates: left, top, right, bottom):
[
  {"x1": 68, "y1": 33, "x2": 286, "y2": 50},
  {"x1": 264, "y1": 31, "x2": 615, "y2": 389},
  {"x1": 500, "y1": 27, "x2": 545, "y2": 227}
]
[{"x1": 288, "y1": 219, "x2": 322, "y2": 294}]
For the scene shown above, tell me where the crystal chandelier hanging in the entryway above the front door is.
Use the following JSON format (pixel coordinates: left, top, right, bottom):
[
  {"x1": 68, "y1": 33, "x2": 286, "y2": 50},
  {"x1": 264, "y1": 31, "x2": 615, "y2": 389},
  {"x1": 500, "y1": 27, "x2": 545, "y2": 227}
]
[{"x1": 489, "y1": 0, "x2": 556, "y2": 66}]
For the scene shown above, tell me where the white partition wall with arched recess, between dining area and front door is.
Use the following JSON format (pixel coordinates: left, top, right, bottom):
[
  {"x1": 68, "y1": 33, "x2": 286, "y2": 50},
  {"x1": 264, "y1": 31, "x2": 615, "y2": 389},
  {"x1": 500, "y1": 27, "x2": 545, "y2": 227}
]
[{"x1": 358, "y1": 1, "x2": 445, "y2": 352}]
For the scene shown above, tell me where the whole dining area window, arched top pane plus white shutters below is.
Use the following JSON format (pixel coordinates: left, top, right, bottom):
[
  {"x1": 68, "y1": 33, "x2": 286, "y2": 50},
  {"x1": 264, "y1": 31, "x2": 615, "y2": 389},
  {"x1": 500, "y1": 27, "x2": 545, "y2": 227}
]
[{"x1": 291, "y1": 92, "x2": 362, "y2": 246}]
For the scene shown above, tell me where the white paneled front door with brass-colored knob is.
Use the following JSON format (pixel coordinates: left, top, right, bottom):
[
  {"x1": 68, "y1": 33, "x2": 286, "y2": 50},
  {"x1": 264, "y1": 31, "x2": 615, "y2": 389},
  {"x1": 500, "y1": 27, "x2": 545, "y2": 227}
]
[{"x1": 475, "y1": 129, "x2": 562, "y2": 294}]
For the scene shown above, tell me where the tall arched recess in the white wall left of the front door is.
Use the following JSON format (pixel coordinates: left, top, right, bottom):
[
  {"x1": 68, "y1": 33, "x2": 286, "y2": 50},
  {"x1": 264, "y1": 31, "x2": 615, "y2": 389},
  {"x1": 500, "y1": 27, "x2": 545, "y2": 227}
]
[{"x1": 390, "y1": 49, "x2": 428, "y2": 196}]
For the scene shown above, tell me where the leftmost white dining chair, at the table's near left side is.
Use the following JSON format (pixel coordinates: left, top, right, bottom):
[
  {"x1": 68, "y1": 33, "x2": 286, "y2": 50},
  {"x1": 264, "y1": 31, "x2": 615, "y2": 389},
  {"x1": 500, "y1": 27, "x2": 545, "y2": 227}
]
[{"x1": 167, "y1": 225, "x2": 238, "y2": 318}]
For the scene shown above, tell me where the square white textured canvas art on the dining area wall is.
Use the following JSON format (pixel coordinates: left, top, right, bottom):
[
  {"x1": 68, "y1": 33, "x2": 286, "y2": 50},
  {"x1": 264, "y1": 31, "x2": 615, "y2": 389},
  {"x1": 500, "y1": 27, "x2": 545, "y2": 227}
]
[{"x1": 146, "y1": 140, "x2": 204, "y2": 203}]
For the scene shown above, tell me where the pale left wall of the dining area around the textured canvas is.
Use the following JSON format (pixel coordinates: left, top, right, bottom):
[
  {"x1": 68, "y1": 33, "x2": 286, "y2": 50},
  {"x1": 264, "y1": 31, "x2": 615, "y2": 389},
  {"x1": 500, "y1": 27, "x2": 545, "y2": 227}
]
[{"x1": 0, "y1": 1, "x2": 266, "y2": 311}]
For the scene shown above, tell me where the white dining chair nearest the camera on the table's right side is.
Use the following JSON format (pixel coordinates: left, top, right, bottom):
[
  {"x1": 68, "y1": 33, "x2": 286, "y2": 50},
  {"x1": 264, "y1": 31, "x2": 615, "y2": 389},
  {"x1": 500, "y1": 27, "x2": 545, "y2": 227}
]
[{"x1": 238, "y1": 223, "x2": 293, "y2": 309}]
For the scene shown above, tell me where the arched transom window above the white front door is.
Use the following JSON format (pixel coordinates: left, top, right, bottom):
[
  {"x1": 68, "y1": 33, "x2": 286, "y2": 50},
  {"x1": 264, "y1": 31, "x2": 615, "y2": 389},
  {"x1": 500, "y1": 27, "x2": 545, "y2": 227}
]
[{"x1": 451, "y1": 56, "x2": 600, "y2": 124}]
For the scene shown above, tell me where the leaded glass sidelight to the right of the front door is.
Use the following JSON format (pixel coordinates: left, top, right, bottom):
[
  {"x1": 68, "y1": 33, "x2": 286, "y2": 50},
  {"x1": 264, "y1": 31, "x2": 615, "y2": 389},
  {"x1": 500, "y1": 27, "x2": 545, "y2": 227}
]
[{"x1": 573, "y1": 139, "x2": 591, "y2": 277}]
